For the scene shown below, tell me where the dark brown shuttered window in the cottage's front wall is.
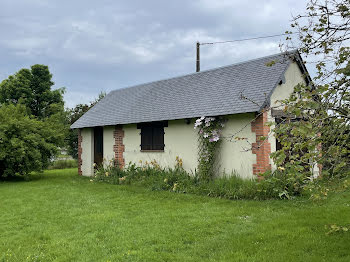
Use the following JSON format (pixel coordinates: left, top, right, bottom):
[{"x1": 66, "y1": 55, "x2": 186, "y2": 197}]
[{"x1": 137, "y1": 122, "x2": 168, "y2": 151}]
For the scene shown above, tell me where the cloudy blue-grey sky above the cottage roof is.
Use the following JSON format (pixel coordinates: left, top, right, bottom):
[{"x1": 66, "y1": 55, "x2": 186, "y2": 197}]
[{"x1": 0, "y1": 0, "x2": 306, "y2": 107}]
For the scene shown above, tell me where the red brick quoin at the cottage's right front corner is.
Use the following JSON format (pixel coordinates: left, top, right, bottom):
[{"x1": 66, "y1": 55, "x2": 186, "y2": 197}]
[{"x1": 251, "y1": 111, "x2": 271, "y2": 175}]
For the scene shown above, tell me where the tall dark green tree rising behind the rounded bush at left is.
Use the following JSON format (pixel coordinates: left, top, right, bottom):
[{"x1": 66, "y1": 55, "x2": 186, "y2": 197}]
[{"x1": 0, "y1": 65, "x2": 64, "y2": 119}]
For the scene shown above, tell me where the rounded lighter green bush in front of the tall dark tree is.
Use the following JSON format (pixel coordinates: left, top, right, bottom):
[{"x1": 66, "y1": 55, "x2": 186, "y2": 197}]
[{"x1": 0, "y1": 104, "x2": 62, "y2": 177}]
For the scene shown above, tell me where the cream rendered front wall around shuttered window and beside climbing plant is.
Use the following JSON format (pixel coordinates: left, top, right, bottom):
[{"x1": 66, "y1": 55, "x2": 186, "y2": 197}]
[{"x1": 123, "y1": 114, "x2": 256, "y2": 178}]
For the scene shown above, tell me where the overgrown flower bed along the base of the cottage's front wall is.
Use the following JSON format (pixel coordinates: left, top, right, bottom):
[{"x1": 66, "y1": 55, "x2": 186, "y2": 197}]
[{"x1": 93, "y1": 160, "x2": 336, "y2": 199}]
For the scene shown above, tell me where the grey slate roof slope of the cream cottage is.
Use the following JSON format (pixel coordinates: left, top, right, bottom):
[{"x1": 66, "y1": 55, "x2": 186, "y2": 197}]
[{"x1": 71, "y1": 52, "x2": 298, "y2": 128}]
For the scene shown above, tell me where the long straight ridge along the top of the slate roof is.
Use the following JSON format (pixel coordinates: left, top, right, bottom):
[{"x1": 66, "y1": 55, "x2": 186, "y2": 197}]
[{"x1": 110, "y1": 49, "x2": 297, "y2": 93}]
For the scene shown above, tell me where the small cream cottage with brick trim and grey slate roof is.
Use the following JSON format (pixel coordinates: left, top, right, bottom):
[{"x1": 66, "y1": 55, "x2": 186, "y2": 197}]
[{"x1": 71, "y1": 51, "x2": 310, "y2": 178}]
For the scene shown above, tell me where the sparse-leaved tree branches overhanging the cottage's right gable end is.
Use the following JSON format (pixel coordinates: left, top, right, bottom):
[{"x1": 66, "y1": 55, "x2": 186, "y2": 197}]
[{"x1": 273, "y1": 0, "x2": 350, "y2": 175}]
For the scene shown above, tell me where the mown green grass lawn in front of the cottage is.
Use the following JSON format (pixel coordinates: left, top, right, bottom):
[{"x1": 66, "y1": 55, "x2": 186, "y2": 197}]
[{"x1": 0, "y1": 169, "x2": 350, "y2": 261}]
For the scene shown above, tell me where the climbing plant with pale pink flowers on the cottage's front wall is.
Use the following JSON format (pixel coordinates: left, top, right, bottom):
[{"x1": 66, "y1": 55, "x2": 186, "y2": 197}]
[{"x1": 194, "y1": 116, "x2": 225, "y2": 180}]
